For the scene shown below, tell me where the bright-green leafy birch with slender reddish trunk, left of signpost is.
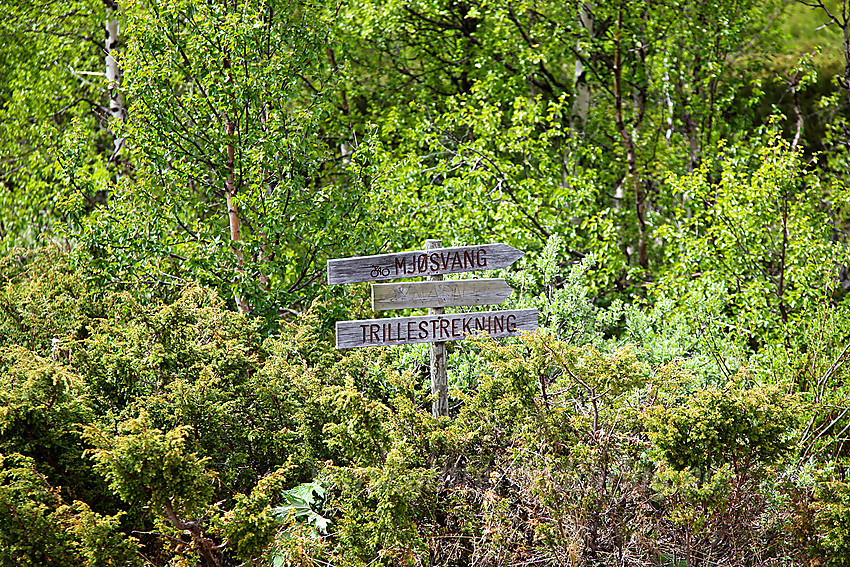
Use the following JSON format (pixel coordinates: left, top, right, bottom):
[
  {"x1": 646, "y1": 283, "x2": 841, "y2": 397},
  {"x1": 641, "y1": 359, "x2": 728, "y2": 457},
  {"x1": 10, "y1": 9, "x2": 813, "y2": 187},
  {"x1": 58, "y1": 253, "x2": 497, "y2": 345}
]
[{"x1": 78, "y1": 0, "x2": 364, "y2": 313}]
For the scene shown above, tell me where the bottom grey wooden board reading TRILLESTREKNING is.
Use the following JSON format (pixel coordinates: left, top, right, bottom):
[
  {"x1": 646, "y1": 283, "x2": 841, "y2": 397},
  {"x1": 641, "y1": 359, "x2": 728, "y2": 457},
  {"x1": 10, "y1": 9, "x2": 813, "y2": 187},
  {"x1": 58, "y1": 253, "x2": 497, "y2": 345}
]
[{"x1": 336, "y1": 309, "x2": 537, "y2": 348}]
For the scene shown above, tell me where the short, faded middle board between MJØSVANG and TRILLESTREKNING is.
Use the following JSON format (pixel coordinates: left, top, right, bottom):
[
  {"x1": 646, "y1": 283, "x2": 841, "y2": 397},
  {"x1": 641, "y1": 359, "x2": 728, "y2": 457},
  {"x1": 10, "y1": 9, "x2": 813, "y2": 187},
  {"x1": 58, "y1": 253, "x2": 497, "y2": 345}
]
[{"x1": 372, "y1": 279, "x2": 513, "y2": 311}]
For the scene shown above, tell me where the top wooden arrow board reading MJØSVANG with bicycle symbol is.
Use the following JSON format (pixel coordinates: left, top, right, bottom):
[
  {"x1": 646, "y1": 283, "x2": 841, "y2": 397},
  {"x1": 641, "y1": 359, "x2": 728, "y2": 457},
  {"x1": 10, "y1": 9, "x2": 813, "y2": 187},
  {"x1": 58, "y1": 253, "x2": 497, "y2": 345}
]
[{"x1": 328, "y1": 244, "x2": 525, "y2": 284}]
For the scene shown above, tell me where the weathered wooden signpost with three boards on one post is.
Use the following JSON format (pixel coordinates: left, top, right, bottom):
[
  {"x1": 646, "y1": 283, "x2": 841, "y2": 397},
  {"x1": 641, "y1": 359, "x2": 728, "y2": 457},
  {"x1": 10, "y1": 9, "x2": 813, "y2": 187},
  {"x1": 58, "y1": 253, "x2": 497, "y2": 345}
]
[{"x1": 328, "y1": 240, "x2": 538, "y2": 417}]
